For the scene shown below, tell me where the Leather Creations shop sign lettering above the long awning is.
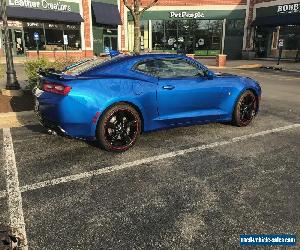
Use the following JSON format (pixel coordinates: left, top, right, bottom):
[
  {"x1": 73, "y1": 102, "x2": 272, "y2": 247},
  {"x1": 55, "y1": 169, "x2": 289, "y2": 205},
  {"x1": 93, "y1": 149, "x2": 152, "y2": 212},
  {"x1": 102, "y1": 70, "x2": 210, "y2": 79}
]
[{"x1": 8, "y1": 0, "x2": 71, "y2": 11}]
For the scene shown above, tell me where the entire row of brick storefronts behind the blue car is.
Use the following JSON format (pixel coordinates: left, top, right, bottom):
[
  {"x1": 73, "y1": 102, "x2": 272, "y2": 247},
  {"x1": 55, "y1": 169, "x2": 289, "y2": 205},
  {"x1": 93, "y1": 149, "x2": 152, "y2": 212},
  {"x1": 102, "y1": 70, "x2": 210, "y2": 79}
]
[{"x1": 0, "y1": 0, "x2": 300, "y2": 59}]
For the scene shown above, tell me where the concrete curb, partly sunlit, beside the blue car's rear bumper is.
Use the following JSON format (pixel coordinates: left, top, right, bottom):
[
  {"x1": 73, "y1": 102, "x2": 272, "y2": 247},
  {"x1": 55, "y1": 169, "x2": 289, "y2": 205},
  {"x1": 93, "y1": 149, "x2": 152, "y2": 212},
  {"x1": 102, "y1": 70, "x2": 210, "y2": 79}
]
[{"x1": 0, "y1": 111, "x2": 38, "y2": 128}]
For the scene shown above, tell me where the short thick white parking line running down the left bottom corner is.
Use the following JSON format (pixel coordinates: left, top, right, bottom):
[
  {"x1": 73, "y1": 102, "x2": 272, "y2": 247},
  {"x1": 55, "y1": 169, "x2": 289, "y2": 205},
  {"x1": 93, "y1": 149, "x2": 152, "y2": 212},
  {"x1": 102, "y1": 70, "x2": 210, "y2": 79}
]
[{"x1": 3, "y1": 128, "x2": 28, "y2": 249}]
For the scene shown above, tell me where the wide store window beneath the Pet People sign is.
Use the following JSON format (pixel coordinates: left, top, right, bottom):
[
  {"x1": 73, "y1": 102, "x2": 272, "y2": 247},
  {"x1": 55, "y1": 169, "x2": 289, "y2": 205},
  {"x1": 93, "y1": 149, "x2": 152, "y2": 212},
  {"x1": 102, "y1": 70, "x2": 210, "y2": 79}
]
[{"x1": 152, "y1": 20, "x2": 223, "y2": 55}]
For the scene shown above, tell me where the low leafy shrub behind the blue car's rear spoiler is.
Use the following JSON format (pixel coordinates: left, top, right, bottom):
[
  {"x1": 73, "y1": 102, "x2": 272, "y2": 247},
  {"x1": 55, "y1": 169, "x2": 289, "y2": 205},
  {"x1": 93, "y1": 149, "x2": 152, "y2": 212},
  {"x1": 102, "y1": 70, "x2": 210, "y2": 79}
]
[{"x1": 25, "y1": 57, "x2": 78, "y2": 89}]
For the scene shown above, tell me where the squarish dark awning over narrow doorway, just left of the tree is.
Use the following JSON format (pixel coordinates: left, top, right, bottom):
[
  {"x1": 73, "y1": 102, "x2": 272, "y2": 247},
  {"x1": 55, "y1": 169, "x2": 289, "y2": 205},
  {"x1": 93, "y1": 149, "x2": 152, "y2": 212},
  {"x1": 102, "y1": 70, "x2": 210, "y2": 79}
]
[{"x1": 92, "y1": 2, "x2": 122, "y2": 25}]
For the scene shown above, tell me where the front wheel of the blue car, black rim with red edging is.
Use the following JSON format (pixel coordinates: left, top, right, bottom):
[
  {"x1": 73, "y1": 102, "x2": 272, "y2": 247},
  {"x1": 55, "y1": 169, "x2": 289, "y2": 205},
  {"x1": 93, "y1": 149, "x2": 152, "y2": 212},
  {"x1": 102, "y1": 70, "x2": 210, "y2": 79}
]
[{"x1": 232, "y1": 90, "x2": 258, "y2": 127}]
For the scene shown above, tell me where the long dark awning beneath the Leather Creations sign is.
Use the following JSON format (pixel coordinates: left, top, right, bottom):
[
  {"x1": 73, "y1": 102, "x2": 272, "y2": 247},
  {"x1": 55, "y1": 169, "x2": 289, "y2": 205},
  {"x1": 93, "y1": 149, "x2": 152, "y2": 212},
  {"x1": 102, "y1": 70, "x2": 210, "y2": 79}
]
[{"x1": 2, "y1": 6, "x2": 83, "y2": 23}]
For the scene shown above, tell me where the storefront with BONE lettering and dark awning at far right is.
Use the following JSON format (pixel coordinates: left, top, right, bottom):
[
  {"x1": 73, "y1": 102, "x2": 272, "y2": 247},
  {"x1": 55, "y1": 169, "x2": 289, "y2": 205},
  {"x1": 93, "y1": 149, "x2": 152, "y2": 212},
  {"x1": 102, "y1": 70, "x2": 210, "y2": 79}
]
[{"x1": 252, "y1": 0, "x2": 300, "y2": 59}]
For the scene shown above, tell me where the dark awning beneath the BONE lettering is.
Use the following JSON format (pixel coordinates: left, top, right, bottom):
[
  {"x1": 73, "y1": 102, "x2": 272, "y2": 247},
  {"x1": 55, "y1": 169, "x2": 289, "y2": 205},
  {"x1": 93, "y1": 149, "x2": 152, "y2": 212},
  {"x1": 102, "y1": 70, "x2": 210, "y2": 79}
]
[{"x1": 251, "y1": 13, "x2": 300, "y2": 26}]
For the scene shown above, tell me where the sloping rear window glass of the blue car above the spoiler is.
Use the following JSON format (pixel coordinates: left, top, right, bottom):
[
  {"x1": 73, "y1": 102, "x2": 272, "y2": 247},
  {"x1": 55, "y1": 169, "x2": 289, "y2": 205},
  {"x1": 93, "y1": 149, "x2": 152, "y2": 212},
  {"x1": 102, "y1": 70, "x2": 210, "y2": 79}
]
[{"x1": 62, "y1": 55, "x2": 124, "y2": 75}]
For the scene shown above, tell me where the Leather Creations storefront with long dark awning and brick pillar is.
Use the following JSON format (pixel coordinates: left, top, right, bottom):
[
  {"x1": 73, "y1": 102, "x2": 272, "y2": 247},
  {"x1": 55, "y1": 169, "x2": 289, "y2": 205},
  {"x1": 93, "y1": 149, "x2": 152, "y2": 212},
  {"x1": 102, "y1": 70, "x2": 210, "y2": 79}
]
[{"x1": 1, "y1": 0, "x2": 92, "y2": 57}]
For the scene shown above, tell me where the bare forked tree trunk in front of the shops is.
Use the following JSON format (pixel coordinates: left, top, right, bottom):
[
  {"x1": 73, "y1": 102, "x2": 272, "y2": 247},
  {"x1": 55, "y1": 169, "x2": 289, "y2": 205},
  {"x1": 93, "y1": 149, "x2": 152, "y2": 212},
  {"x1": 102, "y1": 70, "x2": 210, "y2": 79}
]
[{"x1": 123, "y1": 0, "x2": 158, "y2": 54}]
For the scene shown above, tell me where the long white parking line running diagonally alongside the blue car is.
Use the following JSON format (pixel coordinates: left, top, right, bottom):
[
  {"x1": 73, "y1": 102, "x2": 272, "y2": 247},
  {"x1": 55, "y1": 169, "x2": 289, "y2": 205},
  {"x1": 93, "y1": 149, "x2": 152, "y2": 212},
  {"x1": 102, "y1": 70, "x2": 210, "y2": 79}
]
[{"x1": 20, "y1": 124, "x2": 300, "y2": 192}]
